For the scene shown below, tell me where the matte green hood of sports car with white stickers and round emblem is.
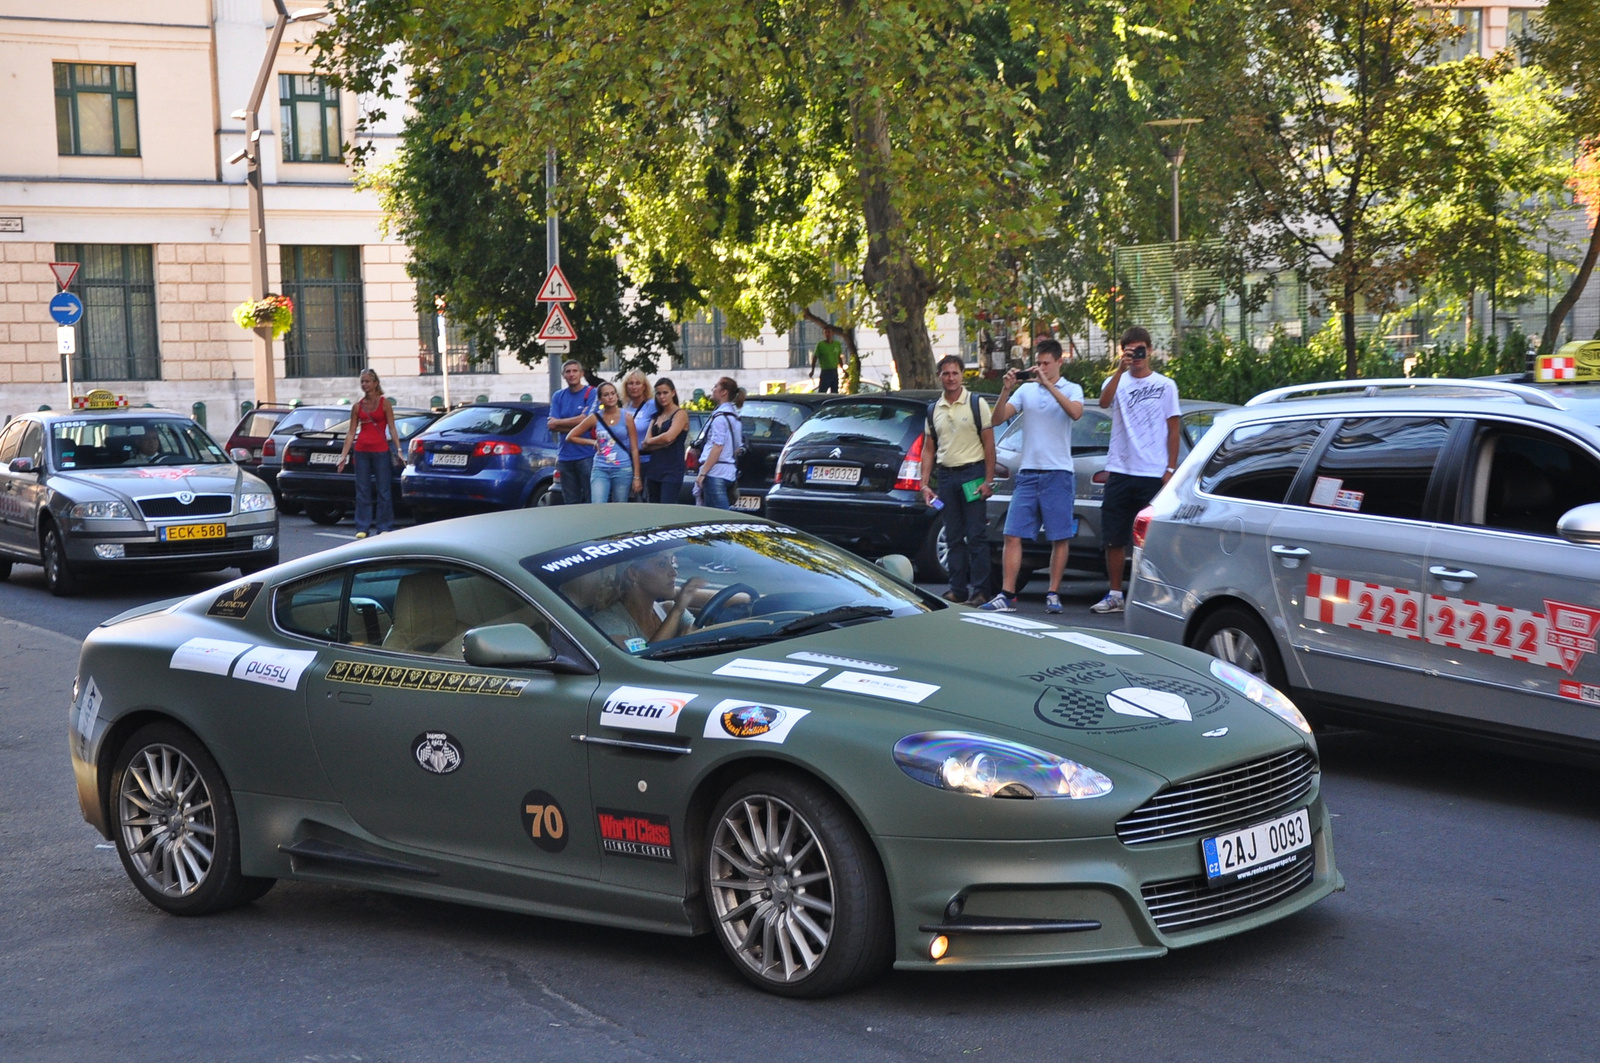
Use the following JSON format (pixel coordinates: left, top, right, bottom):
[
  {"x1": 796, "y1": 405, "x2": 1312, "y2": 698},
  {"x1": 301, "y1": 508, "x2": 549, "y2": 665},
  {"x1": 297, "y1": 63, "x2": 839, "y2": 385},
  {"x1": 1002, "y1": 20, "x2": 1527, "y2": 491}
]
[{"x1": 678, "y1": 608, "x2": 1306, "y2": 780}]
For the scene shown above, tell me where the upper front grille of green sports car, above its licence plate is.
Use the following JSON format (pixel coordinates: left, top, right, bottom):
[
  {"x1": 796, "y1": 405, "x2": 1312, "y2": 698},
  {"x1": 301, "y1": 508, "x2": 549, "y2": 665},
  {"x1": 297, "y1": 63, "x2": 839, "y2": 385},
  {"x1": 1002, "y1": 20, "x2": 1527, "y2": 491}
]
[{"x1": 1117, "y1": 749, "x2": 1317, "y2": 845}]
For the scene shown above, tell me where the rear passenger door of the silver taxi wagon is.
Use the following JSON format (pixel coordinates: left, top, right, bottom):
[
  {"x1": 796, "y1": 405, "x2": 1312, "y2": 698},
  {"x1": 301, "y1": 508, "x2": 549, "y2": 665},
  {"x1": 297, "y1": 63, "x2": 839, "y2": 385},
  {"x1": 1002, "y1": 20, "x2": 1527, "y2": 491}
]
[{"x1": 1267, "y1": 416, "x2": 1453, "y2": 704}]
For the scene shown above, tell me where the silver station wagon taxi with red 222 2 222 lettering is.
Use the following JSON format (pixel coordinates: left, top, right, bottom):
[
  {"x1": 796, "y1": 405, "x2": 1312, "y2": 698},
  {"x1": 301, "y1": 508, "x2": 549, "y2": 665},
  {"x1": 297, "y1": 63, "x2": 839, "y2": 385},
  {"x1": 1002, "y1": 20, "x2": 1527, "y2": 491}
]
[{"x1": 1126, "y1": 379, "x2": 1600, "y2": 759}]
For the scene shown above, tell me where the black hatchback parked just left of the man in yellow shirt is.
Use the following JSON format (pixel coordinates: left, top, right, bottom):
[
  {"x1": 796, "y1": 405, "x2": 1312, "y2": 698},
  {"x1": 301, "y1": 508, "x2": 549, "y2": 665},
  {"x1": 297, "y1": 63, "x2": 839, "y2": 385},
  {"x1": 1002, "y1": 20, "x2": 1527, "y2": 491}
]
[{"x1": 761, "y1": 391, "x2": 939, "y2": 578}]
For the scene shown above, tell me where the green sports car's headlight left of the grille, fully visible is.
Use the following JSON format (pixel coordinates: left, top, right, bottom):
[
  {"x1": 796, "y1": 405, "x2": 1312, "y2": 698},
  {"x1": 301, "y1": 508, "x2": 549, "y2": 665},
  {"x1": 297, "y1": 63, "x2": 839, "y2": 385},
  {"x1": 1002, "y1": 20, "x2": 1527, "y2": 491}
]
[{"x1": 894, "y1": 732, "x2": 1110, "y2": 800}]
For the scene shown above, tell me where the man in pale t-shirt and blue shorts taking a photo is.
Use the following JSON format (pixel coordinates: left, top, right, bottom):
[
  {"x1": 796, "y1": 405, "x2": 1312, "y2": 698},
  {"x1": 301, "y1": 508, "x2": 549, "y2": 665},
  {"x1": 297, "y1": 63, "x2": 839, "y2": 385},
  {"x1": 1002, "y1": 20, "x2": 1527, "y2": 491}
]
[{"x1": 984, "y1": 339, "x2": 1083, "y2": 613}]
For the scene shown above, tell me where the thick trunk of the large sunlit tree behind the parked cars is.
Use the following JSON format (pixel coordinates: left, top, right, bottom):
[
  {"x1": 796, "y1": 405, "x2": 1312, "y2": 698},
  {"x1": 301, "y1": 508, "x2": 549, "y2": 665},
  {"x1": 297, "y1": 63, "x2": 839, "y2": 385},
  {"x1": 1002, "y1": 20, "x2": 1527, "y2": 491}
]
[{"x1": 850, "y1": 84, "x2": 936, "y2": 387}]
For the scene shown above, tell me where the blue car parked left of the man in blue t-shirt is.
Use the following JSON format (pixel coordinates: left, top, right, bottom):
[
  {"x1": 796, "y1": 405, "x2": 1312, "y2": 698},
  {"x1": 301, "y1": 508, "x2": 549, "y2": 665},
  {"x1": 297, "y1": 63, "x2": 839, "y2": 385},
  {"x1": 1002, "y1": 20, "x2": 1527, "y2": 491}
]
[{"x1": 400, "y1": 402, "x2": 557, "y2": 515}]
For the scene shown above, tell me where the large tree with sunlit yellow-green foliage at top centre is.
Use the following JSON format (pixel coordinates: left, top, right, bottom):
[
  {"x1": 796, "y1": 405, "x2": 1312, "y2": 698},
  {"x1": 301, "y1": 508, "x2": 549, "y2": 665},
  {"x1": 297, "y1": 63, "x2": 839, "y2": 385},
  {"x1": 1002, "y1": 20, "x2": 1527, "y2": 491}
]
[{"x1": 320, "y1": 0, "x2": 1187, "y2": 386}]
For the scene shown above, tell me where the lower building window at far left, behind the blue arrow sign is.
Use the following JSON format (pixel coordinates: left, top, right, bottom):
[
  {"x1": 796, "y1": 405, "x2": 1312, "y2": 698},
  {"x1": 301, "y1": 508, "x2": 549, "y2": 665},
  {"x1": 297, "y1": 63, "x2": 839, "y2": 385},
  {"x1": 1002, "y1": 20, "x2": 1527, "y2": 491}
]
[{"x1": 56, "y1": 243, "x2": 162, "y2": 381}]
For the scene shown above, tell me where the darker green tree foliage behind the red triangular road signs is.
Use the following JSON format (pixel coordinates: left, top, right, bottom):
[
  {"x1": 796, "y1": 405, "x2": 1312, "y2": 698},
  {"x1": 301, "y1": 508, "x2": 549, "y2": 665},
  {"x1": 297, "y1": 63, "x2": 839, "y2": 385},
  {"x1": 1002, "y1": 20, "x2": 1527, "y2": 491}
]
[{"x1": 366, "y1": 78, "x2": 691, "y2": 373}]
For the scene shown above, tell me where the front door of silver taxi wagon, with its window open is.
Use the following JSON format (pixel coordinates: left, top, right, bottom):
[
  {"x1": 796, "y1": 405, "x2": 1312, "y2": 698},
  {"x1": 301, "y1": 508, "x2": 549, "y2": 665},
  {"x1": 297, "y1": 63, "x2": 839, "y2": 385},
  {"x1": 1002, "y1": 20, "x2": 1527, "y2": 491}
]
[{"x1": 1422, "y1": 418, "x2": 1600, "y2": 740}]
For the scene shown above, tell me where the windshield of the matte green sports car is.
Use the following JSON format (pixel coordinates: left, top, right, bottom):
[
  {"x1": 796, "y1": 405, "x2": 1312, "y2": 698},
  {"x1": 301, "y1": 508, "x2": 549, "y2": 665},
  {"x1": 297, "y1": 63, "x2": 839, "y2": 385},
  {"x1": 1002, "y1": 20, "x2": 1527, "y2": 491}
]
[{"x1": 522, "y1": 523, "x2": 942, "y2": 658}]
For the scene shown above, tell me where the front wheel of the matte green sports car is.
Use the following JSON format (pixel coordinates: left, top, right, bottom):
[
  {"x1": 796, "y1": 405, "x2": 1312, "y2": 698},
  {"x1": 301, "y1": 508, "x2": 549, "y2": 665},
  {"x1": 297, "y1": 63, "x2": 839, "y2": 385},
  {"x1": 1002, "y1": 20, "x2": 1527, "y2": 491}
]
[{"x1": 702, "y1": 773, "x2": 894, "y2": 997}]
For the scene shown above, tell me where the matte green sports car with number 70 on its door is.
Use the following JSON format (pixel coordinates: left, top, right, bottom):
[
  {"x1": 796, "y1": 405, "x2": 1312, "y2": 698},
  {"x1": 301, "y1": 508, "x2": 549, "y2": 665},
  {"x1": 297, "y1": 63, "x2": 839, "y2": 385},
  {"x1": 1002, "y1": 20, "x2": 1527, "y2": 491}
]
[{"x1": 70, "y1": 506, "x2": 1342, "y2": 996}]
